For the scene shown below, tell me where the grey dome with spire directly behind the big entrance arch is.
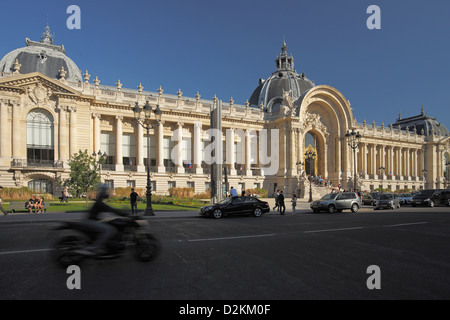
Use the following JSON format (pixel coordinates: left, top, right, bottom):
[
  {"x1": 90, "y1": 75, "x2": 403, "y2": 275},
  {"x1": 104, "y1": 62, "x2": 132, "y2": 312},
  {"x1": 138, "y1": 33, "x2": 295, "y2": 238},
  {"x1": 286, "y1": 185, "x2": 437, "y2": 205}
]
[{"x1": 249, "y1": 43, "x2": 314, "y2": 112}]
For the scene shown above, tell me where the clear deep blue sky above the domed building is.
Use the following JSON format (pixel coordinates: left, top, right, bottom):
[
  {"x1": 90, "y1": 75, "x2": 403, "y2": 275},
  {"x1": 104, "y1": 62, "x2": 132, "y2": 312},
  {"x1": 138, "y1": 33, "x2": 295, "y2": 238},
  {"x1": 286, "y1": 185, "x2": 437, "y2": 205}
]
[{"x1": 0, "y1": 0, "x2": 450, "y2": 128}]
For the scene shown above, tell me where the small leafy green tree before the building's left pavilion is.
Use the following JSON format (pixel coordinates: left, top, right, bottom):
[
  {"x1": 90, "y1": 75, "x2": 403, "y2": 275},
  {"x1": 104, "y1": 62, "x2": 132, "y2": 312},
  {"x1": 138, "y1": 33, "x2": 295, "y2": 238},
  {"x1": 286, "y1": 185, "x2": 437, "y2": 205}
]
[{"x1": 65, "y1": 150, "x2": 101, "y2": 207}]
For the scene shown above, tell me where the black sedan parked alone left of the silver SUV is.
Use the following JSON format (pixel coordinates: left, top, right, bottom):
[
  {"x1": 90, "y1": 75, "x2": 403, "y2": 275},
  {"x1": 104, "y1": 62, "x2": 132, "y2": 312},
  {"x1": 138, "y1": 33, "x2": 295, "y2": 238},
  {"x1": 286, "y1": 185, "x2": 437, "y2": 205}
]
[{"x1": 200, "y1": 196, "x2": 270, "y2": 219}]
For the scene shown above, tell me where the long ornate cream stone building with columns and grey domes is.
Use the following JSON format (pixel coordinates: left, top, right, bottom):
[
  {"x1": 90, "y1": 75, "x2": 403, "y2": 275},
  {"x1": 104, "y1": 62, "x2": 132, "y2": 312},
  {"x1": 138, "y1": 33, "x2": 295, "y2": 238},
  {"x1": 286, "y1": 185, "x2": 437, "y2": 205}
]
[{"x1": 0, "y1": 27, "x2": 450, "y2": 195}]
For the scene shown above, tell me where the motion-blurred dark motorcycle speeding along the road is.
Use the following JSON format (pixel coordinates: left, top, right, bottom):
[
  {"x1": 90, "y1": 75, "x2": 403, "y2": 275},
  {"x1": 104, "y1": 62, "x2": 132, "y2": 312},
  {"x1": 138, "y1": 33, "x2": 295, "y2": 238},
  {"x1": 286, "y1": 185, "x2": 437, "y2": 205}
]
[{"x1": 53, "y1": 216, "x2": 161, "y2": 268}]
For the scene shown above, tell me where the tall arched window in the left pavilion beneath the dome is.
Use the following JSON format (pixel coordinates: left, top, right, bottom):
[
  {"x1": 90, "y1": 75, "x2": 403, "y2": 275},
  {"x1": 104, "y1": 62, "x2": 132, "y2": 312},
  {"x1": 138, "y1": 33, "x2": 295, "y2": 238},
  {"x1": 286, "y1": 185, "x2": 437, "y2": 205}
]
[{"x1": 27, "y1": 109, "x2": 55, "y2": 166}]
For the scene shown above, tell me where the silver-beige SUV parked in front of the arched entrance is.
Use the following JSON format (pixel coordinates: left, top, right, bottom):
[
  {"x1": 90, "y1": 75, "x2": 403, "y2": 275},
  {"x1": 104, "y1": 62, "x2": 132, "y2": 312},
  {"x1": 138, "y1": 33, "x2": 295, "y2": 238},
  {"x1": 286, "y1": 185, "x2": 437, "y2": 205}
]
[{"x1": 310, "y1": 192, "x2": 361, "y2": 213}]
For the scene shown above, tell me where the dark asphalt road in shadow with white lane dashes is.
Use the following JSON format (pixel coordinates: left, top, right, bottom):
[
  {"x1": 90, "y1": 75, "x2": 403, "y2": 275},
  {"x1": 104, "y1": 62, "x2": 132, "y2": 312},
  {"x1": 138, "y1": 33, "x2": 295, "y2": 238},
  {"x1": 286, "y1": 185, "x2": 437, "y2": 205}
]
[{"x1": 0, "y1": 207, "x2": 450, "y2": 300}]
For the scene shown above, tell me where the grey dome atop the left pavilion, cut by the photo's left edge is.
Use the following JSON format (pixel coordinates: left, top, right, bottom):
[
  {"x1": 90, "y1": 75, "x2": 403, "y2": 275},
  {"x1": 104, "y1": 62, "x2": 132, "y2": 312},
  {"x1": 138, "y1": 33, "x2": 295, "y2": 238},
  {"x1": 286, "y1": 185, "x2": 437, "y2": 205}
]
[{"x1": 0, "y1": 26, "x2": 82, "y2": 82}]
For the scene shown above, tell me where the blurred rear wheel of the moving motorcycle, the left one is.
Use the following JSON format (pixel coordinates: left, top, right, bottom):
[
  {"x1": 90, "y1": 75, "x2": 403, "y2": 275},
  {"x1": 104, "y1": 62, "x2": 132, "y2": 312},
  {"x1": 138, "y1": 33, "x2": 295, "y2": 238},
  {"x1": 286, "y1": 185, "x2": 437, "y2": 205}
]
[{"x1": 53, "y1": 235, "x2": 84, "y2": 268}]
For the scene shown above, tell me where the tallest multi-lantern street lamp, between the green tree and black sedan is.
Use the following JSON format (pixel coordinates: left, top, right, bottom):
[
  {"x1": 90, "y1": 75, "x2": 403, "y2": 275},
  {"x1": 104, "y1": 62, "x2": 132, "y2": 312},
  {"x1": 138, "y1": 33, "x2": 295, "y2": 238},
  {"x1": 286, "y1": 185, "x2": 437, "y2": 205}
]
[{"x1": 133, "y1": 101, "x2": 162, "y2": 216}]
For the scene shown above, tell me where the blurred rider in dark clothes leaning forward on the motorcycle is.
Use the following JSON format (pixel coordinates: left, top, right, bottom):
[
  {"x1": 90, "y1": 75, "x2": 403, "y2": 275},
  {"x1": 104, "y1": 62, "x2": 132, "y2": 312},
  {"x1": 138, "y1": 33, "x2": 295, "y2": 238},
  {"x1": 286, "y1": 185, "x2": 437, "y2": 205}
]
[{"x1": 76, "y1": 184, "x2": 127, "y2": 256}]
